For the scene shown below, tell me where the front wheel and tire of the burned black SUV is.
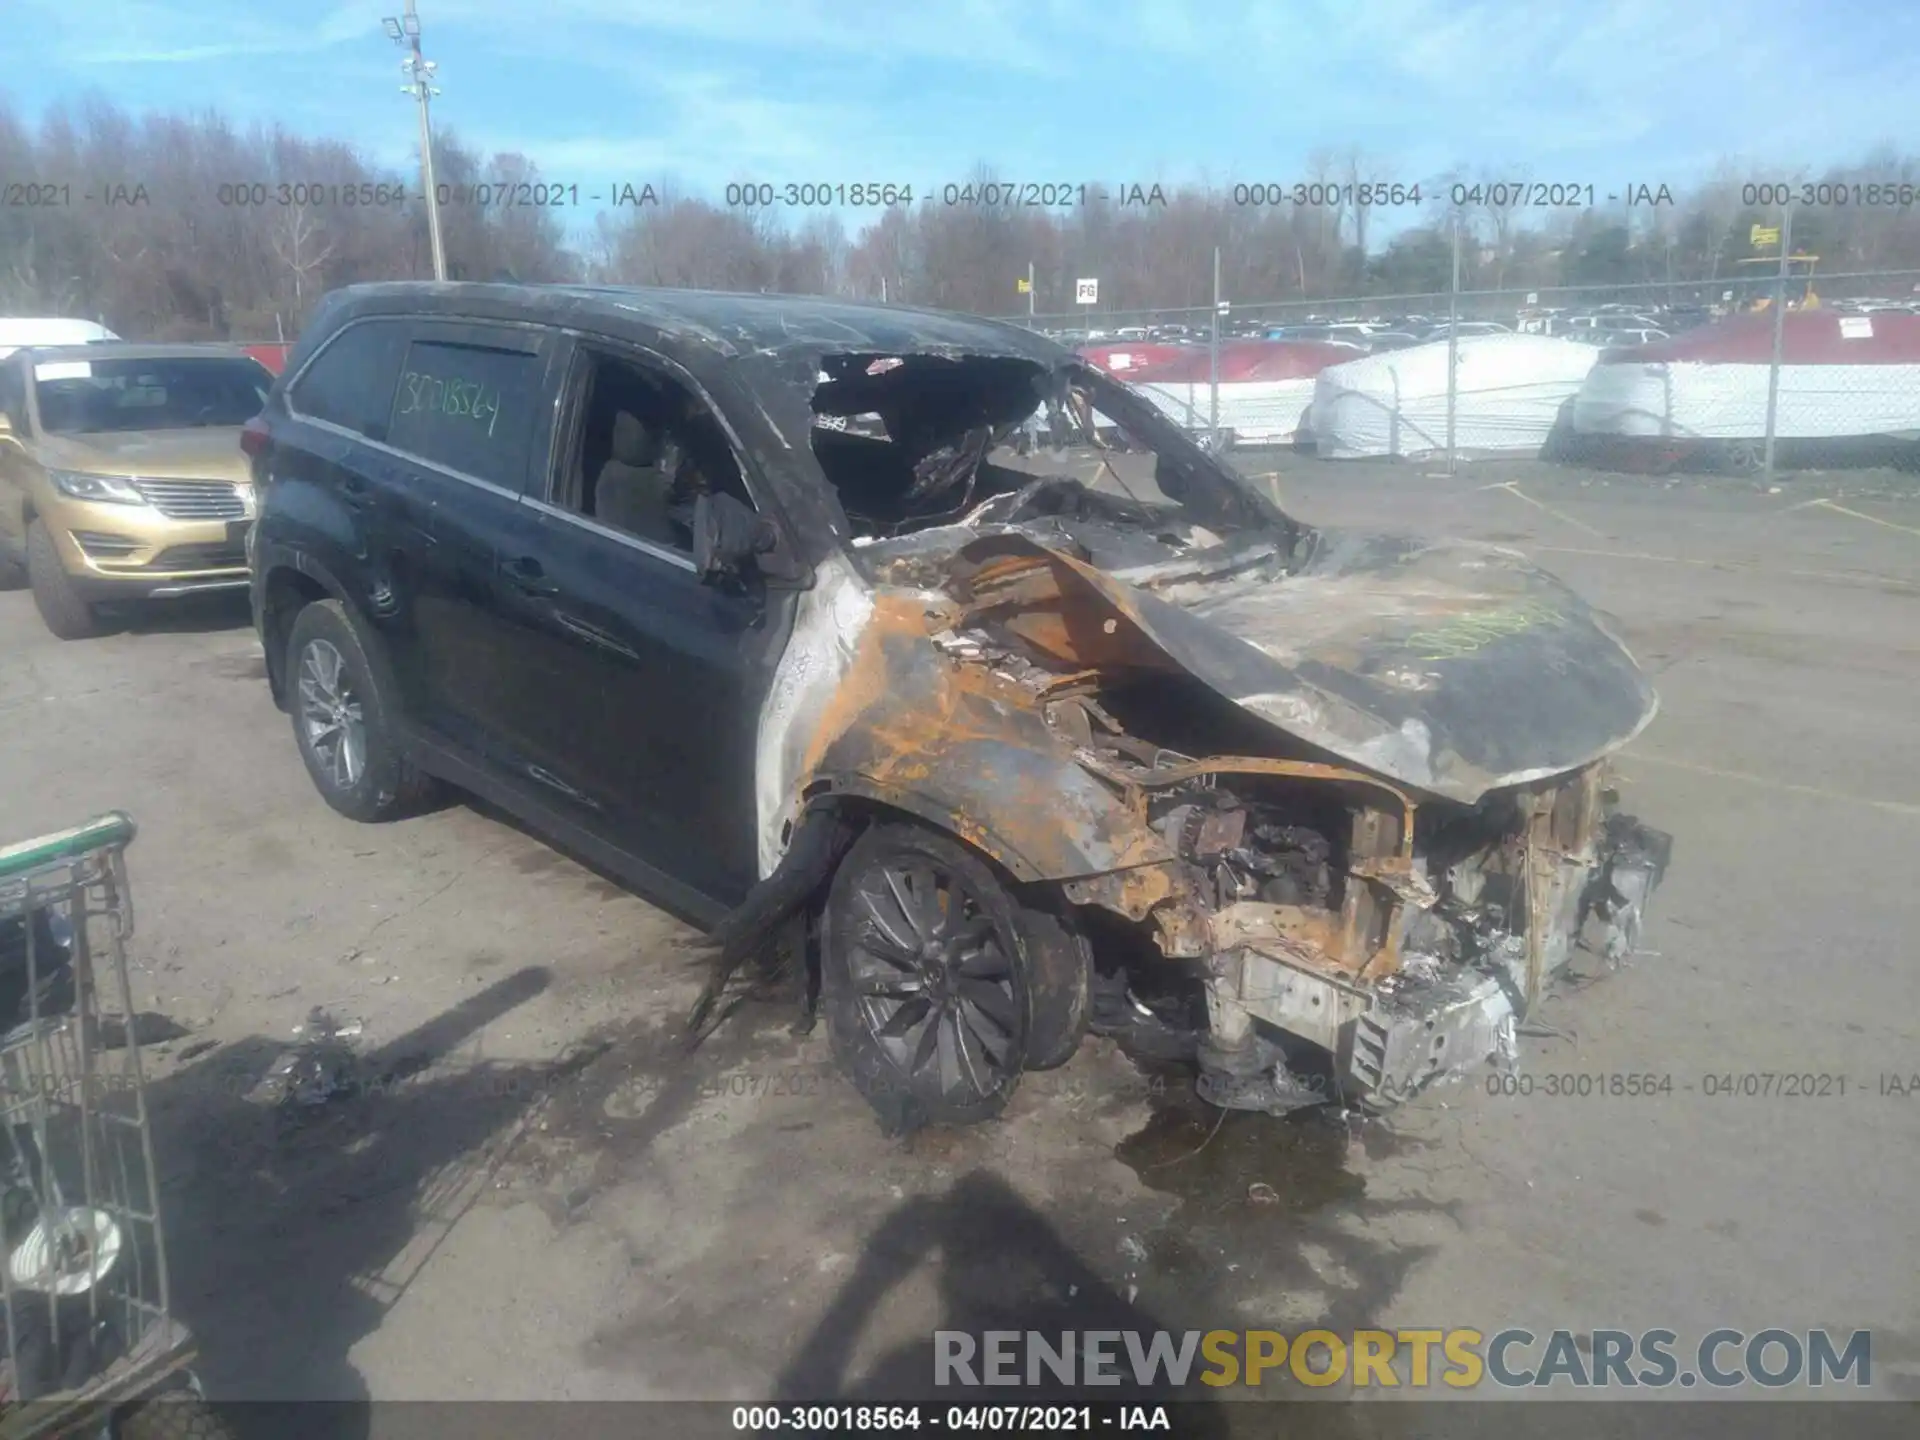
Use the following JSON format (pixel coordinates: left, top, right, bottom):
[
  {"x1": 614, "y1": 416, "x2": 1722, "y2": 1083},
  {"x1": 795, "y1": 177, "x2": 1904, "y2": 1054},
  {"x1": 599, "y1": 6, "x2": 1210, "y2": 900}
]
[{"x1": 820, "y1": 824, "x2": 1035, "y2": 1135}]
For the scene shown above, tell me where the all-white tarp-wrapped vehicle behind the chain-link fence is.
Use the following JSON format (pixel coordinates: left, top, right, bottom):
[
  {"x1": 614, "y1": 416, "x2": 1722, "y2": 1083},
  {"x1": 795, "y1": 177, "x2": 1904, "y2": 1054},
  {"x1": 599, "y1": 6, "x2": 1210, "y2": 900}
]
[{"x1": 1308, "y1": 334, "x2": 1599, "y2": 459}]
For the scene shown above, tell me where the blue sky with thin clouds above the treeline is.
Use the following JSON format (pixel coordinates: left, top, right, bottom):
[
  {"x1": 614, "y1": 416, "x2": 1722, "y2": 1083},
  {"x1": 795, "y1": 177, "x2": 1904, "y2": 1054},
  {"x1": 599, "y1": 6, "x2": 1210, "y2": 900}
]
[{"x1": 0, "y1": 0, "x2": 1920, "y2": 240}]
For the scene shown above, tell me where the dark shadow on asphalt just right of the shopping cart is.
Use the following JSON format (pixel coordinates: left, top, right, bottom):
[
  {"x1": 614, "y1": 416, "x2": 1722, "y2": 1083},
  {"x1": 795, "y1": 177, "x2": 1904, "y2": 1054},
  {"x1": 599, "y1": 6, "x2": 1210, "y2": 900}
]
[{"x1": 148, "y1": 968, "x2": 568, "y2": 1436}]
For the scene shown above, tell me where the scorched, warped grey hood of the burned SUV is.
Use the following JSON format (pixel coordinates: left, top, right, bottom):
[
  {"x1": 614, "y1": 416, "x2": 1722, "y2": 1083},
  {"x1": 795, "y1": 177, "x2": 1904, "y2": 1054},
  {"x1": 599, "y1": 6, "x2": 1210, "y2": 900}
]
[{"x1": 962, "y1": 530, "x2": 1657, "y2": 804}]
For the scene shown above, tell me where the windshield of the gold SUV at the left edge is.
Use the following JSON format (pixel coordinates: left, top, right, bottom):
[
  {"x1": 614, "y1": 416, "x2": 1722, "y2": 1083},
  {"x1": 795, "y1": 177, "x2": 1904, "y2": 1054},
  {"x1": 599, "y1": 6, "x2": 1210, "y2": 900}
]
[{"x1": 35, "y1": 357, "x2": 273, "y2": 436}]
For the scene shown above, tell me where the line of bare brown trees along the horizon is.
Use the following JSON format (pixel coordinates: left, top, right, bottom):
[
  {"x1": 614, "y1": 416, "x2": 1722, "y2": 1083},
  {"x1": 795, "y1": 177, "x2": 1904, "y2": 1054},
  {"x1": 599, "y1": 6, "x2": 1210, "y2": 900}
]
[{"x1": 0, "y1": 100, "x2": 1920, "y2": 338}]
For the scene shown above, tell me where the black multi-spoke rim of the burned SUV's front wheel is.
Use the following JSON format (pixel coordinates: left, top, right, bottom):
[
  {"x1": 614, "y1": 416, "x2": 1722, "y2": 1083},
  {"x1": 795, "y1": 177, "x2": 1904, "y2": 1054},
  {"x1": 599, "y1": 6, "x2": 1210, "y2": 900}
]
[{"x1": 849, "y1": 856, "x2": 1020, "y2": 1096}]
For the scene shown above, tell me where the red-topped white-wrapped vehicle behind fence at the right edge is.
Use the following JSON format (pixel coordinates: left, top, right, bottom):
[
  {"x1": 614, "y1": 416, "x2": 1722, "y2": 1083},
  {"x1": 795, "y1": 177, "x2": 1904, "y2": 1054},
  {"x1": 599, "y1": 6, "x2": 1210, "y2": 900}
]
[{"x1": 1572, "y1": 311, "x2": 1920, "y2": 440}]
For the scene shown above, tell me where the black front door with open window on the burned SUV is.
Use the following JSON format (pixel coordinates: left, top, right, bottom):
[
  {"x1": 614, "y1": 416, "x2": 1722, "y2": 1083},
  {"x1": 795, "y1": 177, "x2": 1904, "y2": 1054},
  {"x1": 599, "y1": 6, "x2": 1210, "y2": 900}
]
[{"x1": 499, "y1": 346, "x2": 793, "y2": 902}]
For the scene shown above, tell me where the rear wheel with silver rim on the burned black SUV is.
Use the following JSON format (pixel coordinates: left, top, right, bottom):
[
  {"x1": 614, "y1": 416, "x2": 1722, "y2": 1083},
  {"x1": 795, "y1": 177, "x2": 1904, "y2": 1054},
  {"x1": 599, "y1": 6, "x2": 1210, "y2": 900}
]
[{"x1": 286, "y1": 599, "x2": 434, "y2": 824}]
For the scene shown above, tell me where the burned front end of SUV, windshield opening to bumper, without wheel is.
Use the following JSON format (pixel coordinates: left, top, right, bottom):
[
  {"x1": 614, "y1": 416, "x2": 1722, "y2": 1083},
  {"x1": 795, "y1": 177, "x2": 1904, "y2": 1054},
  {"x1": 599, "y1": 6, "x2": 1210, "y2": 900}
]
[{"x1": 764, "y1": 355, "x2": 1670, "y2": 1114}]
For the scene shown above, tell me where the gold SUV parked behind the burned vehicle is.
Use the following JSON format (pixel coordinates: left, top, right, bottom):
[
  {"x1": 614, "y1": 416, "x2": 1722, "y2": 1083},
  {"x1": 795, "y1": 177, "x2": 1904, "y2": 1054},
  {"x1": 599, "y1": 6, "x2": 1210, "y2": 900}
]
[{"x1": 0, "y1": 344, "x2": 273, "y2": 639}]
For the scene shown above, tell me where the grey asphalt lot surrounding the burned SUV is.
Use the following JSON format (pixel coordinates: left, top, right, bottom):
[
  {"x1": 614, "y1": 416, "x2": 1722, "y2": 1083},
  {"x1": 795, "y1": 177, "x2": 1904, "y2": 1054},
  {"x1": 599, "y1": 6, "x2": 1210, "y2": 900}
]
[{"x1": 0, "y1": 455, "x2": 1920, "y2": 1420}]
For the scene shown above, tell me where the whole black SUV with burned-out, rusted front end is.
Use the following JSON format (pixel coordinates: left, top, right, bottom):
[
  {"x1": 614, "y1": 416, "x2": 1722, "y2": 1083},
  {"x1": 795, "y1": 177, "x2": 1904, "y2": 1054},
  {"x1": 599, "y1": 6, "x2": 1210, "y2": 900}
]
[{"x1": 244, "y1": 284, "x2": 1668, "y2": 1125}]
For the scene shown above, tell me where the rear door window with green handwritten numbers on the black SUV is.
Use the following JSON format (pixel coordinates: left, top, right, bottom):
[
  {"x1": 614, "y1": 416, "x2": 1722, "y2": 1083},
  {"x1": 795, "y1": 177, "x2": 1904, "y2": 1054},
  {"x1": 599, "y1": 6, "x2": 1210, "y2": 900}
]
[{"x1": 388, "y1": 340, "x2": 541, "y2": 492}]
